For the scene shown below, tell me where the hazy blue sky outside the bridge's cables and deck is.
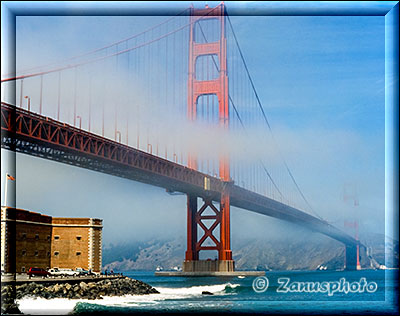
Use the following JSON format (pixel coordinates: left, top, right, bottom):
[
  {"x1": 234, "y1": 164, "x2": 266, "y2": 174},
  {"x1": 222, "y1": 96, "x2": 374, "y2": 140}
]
[{"x1": 1, "y1": 2, "x2": 394, "y2": 247}]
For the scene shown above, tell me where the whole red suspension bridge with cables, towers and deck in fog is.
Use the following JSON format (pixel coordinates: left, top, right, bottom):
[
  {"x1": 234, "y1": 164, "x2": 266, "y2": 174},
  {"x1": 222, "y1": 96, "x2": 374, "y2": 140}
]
[{"x1": 1, "y1": 4, "x2": 361, "y2": 271}]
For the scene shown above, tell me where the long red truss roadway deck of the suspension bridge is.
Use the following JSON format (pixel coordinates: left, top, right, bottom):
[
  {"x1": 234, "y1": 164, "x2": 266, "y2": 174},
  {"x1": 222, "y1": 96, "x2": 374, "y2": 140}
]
[{"x1": 1, "y1": 103, "x2": 358, "y2": 246}]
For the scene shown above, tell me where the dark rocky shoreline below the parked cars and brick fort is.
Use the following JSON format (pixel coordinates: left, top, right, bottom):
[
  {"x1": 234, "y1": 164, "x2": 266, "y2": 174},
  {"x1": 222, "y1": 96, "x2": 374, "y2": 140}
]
[{"x1": 1, "y1": 277, "x2": 159, "y2": 314}]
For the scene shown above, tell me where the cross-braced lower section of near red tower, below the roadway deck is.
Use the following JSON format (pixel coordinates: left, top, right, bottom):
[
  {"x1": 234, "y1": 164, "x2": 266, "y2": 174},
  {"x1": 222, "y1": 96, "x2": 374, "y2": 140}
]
[{"x1": 183, "y1": 191, "x2": 235, "y2": 273}]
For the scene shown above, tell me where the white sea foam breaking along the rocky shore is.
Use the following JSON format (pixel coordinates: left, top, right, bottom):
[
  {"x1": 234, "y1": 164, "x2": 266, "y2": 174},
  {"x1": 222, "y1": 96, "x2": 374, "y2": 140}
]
[{"x1": 17, "y1": 283, "x2": 239, "y2": 315}]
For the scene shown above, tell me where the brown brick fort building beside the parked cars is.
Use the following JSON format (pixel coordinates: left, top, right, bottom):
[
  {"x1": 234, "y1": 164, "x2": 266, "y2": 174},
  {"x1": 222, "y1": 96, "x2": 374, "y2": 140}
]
[{"x1": 1, "y1": 207, "x2": 103, "y2": 273}]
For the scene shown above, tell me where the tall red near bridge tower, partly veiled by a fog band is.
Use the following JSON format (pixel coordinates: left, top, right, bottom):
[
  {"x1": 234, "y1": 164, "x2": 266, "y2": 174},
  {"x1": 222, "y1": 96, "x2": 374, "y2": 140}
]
[{"x1": 183, "y1": 3, "x2": 234, "y2": 272}]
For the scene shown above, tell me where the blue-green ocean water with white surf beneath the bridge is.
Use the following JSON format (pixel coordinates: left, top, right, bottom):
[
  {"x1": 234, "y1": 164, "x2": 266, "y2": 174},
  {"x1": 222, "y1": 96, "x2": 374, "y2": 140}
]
[{"x1": 18, "y1": 270, "x2": 399, "y2": 315}]
